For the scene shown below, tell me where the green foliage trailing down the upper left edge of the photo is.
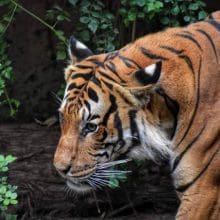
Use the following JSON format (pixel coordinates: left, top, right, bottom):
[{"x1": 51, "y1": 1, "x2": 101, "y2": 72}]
[{"x1": 0, "y1": 1, "x2": 20, "y2": 117}]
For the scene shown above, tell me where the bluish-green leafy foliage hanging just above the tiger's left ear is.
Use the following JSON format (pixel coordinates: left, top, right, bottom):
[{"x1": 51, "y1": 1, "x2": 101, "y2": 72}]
[{"x1": 69, "y1": 0, "x2": 118, "y2": 53}]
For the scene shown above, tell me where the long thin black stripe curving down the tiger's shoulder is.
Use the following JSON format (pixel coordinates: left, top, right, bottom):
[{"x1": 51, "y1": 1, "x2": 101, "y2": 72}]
[{"x1": 176, "y1": 57, "x2": 202, "y2": 148}]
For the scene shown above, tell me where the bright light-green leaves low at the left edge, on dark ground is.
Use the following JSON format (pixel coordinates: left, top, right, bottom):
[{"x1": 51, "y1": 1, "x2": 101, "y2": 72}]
[{"x1": 0, "y1": 154, "x2": 18, "y2": 217}]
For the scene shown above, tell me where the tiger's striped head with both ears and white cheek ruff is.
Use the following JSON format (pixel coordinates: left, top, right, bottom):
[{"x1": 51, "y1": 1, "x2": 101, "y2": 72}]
[{"x1": 54, "y1": 37, "x2": 171, "y2": 192}]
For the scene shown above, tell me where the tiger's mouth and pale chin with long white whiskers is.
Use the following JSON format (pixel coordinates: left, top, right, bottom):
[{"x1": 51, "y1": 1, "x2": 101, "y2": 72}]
[{"x1": 66, "y1": 159, "x2": 131, "y2": 193}]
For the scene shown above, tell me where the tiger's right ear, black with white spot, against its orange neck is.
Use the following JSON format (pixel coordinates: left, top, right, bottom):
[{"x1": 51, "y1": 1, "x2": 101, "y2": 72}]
[{"x1": 133, "y1": 61, "x2": 162, "y2": 89}]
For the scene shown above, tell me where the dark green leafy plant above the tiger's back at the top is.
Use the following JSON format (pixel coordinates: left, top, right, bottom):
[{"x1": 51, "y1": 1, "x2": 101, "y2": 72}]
[{"x1": 119, "y1": 0, "x2": 207, "y2": 40}]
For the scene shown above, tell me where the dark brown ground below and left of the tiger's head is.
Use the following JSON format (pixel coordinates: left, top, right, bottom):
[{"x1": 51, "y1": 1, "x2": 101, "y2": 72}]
[{"x1": 0, "y1": 124, "x2": 179, "y2": 220}]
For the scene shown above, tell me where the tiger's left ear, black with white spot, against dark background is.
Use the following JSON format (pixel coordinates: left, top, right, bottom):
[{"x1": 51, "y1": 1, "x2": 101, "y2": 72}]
[{"x1": 69, "y1": 36, "x2": 93, "y2": 63}]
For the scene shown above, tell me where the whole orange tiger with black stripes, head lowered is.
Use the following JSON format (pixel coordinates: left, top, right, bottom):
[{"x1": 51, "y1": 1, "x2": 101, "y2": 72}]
[{"x1": 53, "y1": 11, "x2": 220, "y2": 220}]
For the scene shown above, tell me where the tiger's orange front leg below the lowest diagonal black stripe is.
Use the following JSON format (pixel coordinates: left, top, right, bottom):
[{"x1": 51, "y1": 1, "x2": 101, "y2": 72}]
[{"x1": 176, "y1": 158, "x2": 220, "y2": 220}]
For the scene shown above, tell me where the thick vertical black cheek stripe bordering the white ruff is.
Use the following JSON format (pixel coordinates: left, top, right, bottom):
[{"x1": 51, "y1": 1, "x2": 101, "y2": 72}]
[{"x1": 128, "y1": 110, "x2": 140, "y2": 147}]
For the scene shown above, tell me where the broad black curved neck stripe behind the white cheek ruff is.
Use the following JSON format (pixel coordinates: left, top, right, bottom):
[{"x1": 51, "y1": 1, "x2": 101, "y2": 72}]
[{"x1": 156, "y1": 88, "x2": 179, "y2": 139}]
